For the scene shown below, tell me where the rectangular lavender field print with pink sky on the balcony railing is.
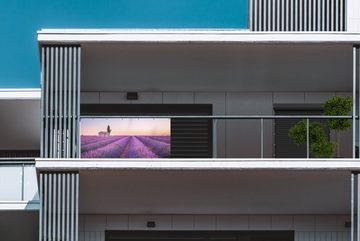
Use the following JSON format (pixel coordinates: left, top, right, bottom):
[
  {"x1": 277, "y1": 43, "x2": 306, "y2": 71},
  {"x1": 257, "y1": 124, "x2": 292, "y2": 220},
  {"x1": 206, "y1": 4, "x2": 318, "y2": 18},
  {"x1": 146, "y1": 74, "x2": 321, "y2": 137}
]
[{"x1": 80, "y1": 118, "x2": 170, "y2": 158}]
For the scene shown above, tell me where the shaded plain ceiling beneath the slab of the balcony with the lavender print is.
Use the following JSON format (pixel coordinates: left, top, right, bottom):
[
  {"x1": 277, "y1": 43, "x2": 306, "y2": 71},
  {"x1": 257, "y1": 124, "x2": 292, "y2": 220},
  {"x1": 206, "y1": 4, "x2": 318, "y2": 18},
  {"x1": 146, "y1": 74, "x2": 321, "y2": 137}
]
[{"x1": 79, "y1": 170, "x2": 350, "y2": 214}]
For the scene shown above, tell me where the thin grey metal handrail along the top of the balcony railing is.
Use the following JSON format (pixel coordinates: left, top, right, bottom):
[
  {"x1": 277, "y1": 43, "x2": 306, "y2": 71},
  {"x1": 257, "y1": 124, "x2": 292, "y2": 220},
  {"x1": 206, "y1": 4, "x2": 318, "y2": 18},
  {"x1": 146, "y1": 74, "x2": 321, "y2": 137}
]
[{"x1": 81, "y1": 115, "x2": 359, "y2": 120}]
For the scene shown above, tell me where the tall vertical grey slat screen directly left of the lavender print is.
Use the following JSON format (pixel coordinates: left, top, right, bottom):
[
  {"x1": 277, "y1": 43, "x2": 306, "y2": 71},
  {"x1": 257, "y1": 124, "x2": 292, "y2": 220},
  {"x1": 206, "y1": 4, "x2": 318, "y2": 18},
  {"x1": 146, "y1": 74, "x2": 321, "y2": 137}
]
[{"x1": 41, "y1": 46, "x2": 81, "y2": 158}]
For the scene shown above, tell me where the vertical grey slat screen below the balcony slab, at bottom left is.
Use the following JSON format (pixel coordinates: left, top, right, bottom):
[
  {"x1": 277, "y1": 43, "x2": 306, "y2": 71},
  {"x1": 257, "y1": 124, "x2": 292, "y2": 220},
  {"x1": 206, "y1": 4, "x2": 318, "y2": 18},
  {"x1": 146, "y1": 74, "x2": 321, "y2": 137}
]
[{"x1": 39, "y1": 172, "x2": 79, "y2": 241}]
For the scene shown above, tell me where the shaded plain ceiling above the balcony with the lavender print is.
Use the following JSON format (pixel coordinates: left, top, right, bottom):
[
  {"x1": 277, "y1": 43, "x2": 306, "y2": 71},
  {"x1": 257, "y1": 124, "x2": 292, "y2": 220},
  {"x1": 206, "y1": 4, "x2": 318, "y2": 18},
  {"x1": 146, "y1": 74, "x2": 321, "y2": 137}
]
[{"x1": 81, "y1": 43, "x2": 352, "y2": 92}]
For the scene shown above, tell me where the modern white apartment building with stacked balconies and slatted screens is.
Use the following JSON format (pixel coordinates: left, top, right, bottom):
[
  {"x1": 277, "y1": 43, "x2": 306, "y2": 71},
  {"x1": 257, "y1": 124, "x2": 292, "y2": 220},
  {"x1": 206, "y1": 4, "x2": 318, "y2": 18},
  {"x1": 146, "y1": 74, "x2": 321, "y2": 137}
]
[{"x1": 0, "y1": 0, "x2": 360, "y2": 241}]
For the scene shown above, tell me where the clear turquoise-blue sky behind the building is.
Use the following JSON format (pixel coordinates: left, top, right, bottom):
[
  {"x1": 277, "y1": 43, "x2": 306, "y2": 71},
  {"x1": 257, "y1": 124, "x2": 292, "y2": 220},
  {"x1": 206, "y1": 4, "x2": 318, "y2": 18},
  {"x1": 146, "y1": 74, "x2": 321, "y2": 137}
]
[{"x1": 0, "y1": 0, "x2": 247, "y2": 88}]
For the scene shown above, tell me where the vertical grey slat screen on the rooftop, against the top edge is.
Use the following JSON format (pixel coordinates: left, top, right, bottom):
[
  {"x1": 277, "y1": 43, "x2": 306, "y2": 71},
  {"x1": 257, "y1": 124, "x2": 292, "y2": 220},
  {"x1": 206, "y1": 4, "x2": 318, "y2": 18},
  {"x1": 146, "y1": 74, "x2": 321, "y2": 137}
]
[{"x1": 249, "y1": 0, "x2": 347, "y2": 31}]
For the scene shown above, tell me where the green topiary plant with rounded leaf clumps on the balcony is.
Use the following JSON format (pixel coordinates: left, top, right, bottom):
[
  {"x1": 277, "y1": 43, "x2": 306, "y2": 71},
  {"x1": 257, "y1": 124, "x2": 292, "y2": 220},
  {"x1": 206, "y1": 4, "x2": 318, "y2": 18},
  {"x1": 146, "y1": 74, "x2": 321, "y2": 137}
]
[{"x1": 288, "y1": 96, "x2": 352, "y2": 158}]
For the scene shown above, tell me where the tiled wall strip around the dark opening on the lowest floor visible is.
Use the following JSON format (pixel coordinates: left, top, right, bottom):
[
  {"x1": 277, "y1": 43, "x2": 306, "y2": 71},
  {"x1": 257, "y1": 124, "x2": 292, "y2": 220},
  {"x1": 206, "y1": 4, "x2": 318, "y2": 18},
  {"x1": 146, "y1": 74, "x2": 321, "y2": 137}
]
[{"x1": 79, "y1": 214, "x2": 350, "y2": 241}]
